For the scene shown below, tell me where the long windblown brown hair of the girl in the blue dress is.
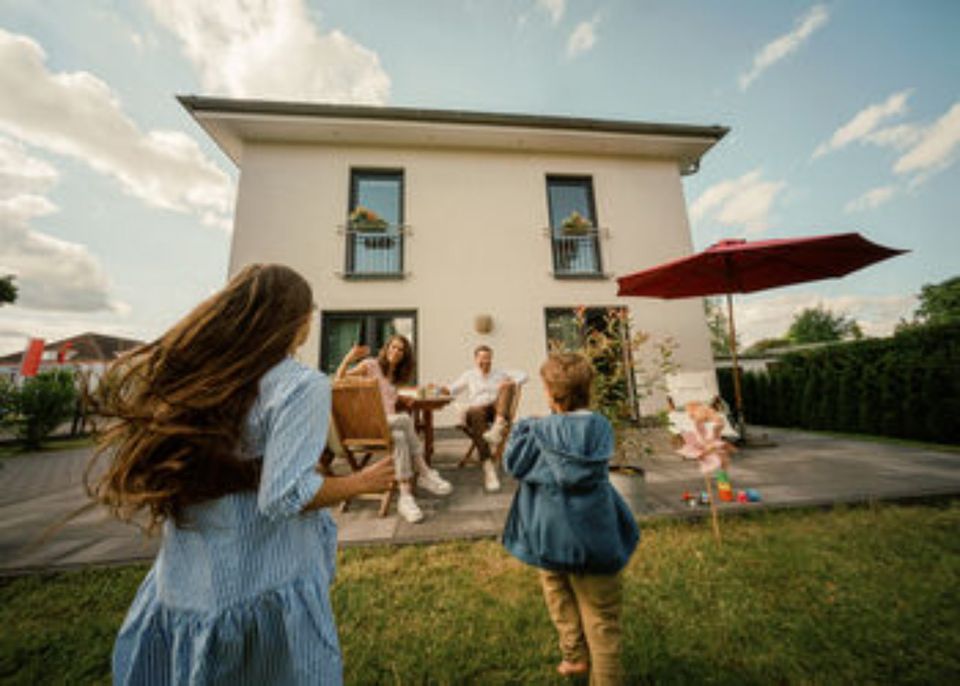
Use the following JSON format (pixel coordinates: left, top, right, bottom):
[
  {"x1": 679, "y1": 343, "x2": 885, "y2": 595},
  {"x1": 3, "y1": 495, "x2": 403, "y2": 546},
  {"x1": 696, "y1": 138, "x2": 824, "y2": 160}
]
[{"x1": 85, "y1": 264, "x2": 313, "y2": 532}]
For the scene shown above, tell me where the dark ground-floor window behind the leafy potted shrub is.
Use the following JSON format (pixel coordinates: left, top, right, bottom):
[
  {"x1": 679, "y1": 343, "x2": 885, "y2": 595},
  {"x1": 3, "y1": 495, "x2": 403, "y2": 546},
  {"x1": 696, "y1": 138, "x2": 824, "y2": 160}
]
[{"x1": 544, "y1": 307, "x2": 639, "y2": 419}]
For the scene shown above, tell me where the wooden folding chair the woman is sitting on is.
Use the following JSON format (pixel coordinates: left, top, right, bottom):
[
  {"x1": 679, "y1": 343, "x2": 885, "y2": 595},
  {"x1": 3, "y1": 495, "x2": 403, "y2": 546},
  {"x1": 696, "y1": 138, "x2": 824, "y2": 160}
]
[{"x1": 323, "y1": 379, "x2": 397, "y2": 517}]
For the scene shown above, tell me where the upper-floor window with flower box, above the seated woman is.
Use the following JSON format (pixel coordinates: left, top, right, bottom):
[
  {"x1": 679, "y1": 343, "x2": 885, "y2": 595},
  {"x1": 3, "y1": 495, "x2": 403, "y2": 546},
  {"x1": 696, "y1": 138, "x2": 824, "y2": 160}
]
[{"x1": 346, "y1": 169, "x2": 403, "y2": 277}]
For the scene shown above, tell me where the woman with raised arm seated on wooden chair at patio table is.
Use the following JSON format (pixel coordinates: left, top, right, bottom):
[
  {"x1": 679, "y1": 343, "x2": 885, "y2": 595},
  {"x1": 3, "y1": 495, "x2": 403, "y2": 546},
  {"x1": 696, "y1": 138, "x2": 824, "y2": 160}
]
[{"x1": 336, "y1": 336, "x2": 453, "y2": 523}]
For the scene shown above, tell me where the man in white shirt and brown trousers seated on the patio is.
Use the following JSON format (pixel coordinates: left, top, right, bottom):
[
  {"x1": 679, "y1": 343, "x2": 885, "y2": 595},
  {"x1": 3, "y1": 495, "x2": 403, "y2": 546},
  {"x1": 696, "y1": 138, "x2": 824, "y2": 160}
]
[{"x1": 440, "y1": 345, "x2": 527, "y2": 491}]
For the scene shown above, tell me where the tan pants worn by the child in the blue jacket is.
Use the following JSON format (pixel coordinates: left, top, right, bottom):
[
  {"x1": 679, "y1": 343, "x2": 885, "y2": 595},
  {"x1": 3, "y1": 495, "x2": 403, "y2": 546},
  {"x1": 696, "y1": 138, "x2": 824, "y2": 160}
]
[{"x1": 540, "y1": 570, "x2": 623, "y2": 686}]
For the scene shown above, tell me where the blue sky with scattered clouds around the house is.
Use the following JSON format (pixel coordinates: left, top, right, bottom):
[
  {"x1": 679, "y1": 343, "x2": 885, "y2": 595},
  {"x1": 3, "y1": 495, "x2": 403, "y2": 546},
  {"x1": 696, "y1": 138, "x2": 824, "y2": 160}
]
[{"x1": 0, "y1": 0, "x2": 960, "y2": 354}]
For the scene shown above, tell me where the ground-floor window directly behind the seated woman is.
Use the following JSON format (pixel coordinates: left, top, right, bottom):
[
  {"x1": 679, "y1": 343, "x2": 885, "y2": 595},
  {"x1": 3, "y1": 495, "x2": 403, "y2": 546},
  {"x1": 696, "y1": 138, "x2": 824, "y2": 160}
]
[{"x1": 320, "y1": 310, "x2": 417, "y2": 383}]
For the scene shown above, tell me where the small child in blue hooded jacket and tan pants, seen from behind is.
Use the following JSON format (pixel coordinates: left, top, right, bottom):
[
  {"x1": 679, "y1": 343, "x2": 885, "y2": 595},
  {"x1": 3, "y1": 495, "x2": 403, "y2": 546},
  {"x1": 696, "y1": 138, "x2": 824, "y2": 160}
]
[{"x1": 503, "y1": 353, "x2": 640, "y2": 684}]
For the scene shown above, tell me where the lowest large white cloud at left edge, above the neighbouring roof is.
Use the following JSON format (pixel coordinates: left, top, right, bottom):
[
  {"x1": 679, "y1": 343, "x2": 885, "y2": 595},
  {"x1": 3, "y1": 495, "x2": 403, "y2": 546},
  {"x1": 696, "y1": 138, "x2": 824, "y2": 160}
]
[{"x1": 0, "y1": 136, "x2": 122, "y2": 317}]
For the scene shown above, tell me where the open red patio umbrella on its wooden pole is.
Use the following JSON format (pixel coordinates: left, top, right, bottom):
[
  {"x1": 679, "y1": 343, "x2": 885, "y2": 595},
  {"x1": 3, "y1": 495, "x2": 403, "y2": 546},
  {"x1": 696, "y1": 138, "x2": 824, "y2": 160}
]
[{"x1": 617, "y1": 233, "x2": 908, "y2": 436}]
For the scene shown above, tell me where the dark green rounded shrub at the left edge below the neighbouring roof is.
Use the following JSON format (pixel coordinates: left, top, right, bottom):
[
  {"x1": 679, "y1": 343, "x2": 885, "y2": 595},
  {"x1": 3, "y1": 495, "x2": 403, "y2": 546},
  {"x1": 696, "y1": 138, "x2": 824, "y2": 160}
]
[{"x1": 4, "y1": 369, "x2": 78, "y2": 449}]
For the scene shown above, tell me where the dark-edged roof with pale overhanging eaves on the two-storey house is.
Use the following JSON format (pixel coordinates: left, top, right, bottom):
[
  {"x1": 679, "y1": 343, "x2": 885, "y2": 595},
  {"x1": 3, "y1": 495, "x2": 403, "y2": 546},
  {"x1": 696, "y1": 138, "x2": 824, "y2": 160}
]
[{"x1": 177, "y1": 95, "x2": 729, "y2": 174}]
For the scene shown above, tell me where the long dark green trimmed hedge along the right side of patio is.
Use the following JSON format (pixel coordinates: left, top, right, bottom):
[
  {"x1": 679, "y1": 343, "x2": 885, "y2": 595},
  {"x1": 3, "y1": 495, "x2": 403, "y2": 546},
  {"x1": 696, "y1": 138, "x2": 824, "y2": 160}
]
[{"x1": 719, "y1": 323, "x2": 960, "y2": 444}]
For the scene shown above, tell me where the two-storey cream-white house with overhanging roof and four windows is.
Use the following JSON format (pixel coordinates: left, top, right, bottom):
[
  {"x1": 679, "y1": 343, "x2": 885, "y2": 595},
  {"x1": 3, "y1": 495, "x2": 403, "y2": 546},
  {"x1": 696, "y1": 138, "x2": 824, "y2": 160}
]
[{"x1": 180, "y1": 96, "x2": 727, "y2": 424}]
